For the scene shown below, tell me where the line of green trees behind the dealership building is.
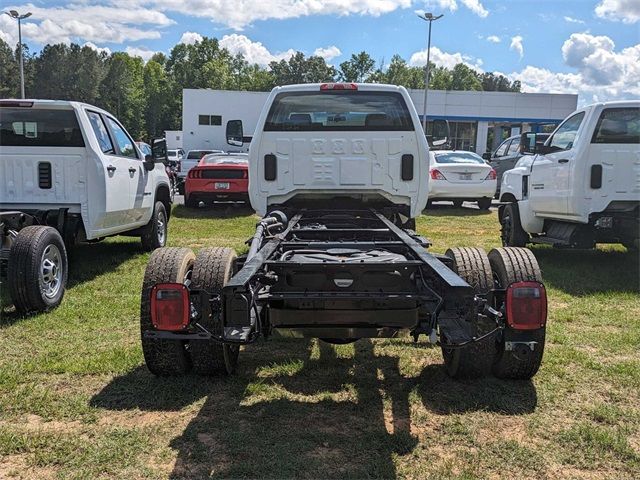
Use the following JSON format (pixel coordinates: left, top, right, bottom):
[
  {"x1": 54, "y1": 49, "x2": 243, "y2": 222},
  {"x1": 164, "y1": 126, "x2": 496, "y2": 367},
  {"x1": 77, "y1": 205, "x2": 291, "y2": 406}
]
[{"x1": 0, "y1": 37, "x2": 520, "y2": 139}]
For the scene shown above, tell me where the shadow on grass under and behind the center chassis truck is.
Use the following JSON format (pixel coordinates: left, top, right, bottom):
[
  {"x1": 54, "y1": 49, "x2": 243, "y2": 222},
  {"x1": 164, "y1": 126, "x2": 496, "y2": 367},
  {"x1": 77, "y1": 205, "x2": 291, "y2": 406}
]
[{"x1": 91, "y1": 340, "x2": 537, "y2": 479}]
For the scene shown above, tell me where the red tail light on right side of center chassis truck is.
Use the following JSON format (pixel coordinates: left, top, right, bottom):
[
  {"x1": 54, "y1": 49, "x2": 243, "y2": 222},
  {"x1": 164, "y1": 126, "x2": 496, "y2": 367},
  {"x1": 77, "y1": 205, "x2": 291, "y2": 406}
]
[{"x1": 506, "y1": 282, "x2": 547, "y2": 330}]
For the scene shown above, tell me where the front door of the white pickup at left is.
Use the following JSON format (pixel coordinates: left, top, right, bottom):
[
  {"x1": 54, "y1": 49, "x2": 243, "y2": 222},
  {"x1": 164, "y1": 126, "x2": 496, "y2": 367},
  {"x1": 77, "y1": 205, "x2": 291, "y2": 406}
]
[{"x1": 107, "y1": 117, "x2": 153, "y2": 226}]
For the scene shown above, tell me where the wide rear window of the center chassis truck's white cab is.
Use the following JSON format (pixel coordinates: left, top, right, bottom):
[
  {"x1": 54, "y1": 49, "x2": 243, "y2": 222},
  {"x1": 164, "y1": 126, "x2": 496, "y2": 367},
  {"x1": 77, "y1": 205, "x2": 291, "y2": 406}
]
[{"x1": 264, "y1": 90, "x2": 414, "y2": 132}]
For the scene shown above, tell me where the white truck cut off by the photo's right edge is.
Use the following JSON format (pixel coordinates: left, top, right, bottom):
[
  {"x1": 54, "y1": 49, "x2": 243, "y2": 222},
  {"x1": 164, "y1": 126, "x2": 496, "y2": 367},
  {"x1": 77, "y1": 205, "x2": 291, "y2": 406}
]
[{"x1": 499, "y1": 101, "x2": 640, "y2": 249}]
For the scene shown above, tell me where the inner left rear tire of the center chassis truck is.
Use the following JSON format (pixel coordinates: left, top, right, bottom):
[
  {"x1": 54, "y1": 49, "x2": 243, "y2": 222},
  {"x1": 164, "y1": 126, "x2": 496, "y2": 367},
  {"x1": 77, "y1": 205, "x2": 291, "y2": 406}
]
[{"x1": 189, "y1": 247, "x2": 240, "y2": 375}]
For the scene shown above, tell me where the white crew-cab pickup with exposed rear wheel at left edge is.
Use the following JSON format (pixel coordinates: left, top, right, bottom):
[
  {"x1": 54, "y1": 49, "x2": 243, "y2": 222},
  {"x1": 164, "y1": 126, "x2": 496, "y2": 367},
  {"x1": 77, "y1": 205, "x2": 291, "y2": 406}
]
[{"x1": 0, "y1": 100, "x2": 171, "y2": 313}]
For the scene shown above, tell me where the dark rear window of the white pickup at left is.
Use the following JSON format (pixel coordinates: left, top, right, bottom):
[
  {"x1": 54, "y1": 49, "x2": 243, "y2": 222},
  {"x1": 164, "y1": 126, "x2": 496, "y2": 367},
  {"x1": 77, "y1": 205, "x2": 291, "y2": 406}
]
[{"x1": 0, "y1": 107, "x2": 84, "y2": 147}]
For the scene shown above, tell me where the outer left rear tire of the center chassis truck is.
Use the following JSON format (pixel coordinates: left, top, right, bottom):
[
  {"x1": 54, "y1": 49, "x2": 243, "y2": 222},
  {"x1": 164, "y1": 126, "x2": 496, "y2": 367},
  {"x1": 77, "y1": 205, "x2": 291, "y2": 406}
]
[{"x1": 140, "y1": 247, "x2": 195, "y2": 376}]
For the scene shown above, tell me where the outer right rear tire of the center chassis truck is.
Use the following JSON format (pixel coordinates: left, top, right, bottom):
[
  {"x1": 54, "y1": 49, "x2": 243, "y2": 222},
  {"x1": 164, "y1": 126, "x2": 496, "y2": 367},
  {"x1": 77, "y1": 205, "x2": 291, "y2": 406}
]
[{"x1": 489, "y1": 247, "x2": 546, "y2": 379}]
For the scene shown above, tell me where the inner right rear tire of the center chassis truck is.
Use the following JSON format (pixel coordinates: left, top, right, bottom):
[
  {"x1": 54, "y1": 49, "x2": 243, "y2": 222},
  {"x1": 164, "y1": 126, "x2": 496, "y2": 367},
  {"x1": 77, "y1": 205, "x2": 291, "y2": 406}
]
[{"x1": 441, "y1": 247, "x2": 495, "y2": 378}]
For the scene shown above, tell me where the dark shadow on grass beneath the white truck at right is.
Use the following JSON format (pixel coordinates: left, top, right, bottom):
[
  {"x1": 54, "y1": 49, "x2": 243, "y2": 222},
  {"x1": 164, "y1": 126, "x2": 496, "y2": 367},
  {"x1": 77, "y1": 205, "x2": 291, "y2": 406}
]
[{"x1": 531, "y1": 247, "x2": 640, "y2": 296}]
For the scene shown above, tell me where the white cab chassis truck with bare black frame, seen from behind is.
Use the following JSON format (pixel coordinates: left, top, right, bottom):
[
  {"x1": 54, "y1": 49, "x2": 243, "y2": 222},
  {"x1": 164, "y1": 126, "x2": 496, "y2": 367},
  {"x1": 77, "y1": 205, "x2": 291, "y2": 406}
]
[{"x1": 140, "y1": 83, "x2": 547, "y2": 378}]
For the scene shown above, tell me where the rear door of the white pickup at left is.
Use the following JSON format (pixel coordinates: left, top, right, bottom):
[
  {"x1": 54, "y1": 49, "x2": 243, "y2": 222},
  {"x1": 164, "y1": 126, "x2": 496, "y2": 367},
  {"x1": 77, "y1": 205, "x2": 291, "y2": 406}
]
[{"x1": 86, "y1": 110, "x2": 130, "y2": 230}]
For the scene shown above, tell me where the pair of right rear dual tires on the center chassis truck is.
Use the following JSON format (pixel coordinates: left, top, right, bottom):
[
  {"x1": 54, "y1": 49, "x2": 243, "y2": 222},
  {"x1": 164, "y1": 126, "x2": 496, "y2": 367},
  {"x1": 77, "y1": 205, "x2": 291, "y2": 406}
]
[{"x1": 441, "y1": 247, "x2": 545, "y2": 379}]
